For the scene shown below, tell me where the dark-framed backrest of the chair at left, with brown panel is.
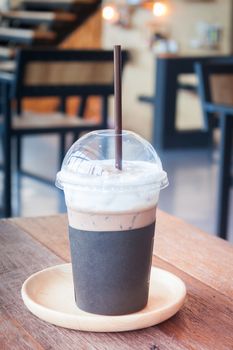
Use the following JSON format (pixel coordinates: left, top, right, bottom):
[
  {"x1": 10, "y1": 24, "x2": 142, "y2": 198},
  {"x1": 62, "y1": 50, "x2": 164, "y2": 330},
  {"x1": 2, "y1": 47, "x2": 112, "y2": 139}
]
[{"x1": 13, "y1": 49, "x2": 127, "y2": 98}]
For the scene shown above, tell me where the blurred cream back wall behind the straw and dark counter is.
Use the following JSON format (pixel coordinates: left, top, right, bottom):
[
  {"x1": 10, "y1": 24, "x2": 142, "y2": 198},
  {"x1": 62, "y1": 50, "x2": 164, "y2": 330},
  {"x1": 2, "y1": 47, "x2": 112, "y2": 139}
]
[{"x1": 102, "y1": 0, "x2": 232, "y2": 140}]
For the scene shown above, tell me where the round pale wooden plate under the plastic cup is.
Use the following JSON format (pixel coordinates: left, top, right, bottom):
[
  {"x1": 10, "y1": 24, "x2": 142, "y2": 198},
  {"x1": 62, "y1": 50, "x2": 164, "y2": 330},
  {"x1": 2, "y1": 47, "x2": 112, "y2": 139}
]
[{"x1": 21, "y1": 264, "x2": 186, "y2": 332}]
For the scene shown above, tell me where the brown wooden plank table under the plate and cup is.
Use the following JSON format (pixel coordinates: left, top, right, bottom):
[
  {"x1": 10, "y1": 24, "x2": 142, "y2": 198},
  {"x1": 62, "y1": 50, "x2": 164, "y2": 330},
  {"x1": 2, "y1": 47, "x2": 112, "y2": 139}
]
[{"x1": 0, "y1": 212, "x2": 233, "y2": 350}]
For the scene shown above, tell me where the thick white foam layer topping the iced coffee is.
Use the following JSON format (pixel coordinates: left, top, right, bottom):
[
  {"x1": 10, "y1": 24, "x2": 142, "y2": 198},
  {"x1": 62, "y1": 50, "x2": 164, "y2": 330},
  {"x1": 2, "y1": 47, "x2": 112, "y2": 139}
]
[{"x1": 60, "y1": 160, "x2": 164, "y2": 213}]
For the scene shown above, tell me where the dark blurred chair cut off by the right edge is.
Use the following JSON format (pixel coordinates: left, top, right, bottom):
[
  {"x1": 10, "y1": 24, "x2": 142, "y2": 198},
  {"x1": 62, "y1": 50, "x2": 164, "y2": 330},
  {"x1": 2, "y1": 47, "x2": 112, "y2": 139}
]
[{"x1": 195, "y1": 58, "x2": 233, "y2": 239}]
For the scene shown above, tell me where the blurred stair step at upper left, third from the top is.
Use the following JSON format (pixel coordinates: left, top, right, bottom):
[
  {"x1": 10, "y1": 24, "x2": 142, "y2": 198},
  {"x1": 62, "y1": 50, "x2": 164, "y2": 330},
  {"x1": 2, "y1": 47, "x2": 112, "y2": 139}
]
[{"x1": 0, "y1": 27, "x2": 56, "y2": 44}]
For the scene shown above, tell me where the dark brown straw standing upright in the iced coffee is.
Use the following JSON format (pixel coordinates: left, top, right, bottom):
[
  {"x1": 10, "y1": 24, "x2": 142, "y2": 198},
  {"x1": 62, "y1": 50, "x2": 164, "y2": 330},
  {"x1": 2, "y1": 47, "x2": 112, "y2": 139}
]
[{"x1": 114, "y1": 45, "x2": 122, "y2": 170}]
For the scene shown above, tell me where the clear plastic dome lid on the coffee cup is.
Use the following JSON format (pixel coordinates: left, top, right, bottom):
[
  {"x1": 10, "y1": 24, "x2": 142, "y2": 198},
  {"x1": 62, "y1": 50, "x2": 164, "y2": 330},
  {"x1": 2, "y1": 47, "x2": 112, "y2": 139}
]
[{"x1": 56, "y1": 130, "x2": 168, "y2": 190}]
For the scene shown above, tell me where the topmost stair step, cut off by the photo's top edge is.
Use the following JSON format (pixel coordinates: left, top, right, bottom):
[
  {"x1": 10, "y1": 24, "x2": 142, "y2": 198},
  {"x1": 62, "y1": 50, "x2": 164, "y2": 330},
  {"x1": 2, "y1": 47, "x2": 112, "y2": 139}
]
[{"x1": 22, "y1": 0, "x2": 97, "y2": 10}]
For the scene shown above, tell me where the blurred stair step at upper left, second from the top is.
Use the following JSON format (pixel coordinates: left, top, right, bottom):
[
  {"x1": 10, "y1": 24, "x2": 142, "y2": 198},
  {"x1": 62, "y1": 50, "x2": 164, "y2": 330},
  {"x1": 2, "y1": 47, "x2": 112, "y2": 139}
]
[{"x1": 0, "y1": 10, "x2": 76, "y2": 24}]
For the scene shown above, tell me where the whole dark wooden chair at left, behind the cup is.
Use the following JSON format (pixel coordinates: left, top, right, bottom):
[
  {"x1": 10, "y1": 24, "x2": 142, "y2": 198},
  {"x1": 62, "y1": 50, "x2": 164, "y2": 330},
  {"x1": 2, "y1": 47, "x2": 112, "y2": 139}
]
[{"x1": 0, "y1": 49, "x2": 127, "y2": 217}]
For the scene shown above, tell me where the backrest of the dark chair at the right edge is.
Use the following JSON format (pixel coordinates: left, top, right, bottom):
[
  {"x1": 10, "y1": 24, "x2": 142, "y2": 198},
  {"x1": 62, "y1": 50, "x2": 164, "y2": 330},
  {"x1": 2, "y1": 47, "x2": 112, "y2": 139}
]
[{"x1": 195, "y1": 57, "x2": 233, "y2": 129}]
